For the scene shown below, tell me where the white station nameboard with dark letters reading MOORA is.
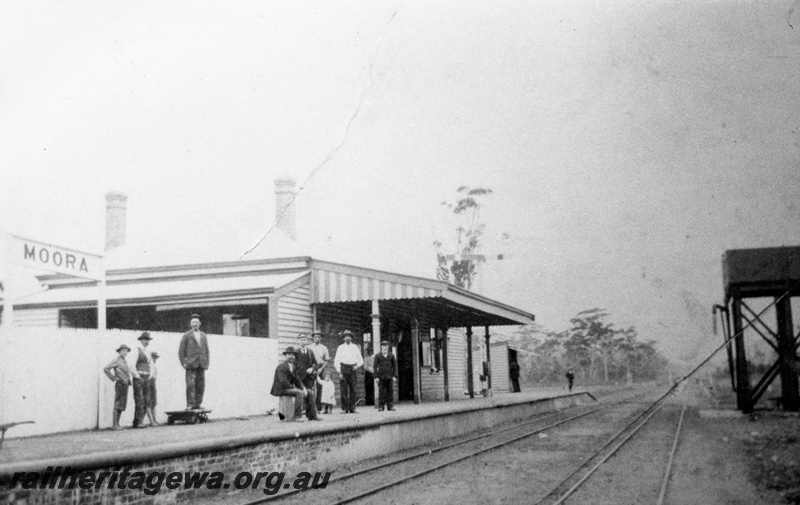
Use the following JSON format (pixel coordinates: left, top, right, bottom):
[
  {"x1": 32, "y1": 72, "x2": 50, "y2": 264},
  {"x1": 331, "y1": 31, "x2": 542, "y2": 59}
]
[{"x1": 11, "y1": 236, "x2": 104, "y2": 281}]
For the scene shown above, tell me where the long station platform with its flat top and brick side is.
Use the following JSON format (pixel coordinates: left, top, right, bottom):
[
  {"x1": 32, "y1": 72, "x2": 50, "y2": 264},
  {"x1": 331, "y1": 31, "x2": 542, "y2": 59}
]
[{"x1": 0, "y1": 388, "x2": 595, "y2": 503}]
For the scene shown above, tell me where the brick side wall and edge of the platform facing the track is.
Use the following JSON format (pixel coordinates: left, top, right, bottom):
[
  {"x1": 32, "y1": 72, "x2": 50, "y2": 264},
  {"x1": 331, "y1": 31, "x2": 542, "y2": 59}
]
[{"x1": 0, "y1": 393, "x2": 594, "y2": 505}]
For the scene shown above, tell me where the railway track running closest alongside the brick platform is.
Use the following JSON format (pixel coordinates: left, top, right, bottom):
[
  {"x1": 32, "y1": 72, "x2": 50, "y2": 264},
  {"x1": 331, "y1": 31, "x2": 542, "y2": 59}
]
[{"x1": 233, "y1": 384, "x2": 668, "y2": 505}]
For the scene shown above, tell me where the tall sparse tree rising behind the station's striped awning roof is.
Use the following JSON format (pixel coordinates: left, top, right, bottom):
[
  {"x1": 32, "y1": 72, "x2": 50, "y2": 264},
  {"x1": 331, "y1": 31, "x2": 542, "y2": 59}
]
[{"x1": 433, "y1": 186, "x2": 492, "y2": 290}]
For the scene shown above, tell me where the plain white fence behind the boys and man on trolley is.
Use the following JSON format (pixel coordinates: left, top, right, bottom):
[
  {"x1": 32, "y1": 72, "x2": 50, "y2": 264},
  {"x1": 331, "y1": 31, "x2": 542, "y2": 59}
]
[{"x1": 0, "y1": 328, "x2": 278, "y2": 437}]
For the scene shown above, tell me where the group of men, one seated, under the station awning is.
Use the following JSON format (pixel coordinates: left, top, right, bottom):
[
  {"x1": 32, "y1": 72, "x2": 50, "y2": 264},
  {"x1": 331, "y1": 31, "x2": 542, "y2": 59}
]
[{"x1": 271, "y1": 330, "x2": 397, "y2": 421}]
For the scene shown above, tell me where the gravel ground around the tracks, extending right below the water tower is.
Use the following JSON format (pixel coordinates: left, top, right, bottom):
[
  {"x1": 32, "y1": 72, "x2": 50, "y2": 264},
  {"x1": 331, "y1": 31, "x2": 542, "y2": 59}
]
[{"x1": 192, "y1": 383, "x2": 800, "y2": 505}]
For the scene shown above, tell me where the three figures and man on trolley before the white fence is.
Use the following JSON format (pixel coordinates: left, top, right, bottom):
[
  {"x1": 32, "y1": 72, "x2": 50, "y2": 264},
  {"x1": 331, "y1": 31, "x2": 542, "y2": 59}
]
[{"x1": 103, "y1": 314, "x2": 210, "y2": 430}]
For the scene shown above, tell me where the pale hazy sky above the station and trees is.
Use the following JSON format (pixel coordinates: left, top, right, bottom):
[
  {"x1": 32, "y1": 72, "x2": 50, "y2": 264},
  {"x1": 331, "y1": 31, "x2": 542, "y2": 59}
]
[{"x1": 0, "y1": 0, "x2": 800, "y2": 361}]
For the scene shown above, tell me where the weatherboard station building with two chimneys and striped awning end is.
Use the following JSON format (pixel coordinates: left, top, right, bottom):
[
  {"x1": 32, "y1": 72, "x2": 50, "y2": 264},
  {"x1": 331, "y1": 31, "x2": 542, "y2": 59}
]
[{"x1": 9, "y1": 179, "x2": 534, "y2": 403}]
